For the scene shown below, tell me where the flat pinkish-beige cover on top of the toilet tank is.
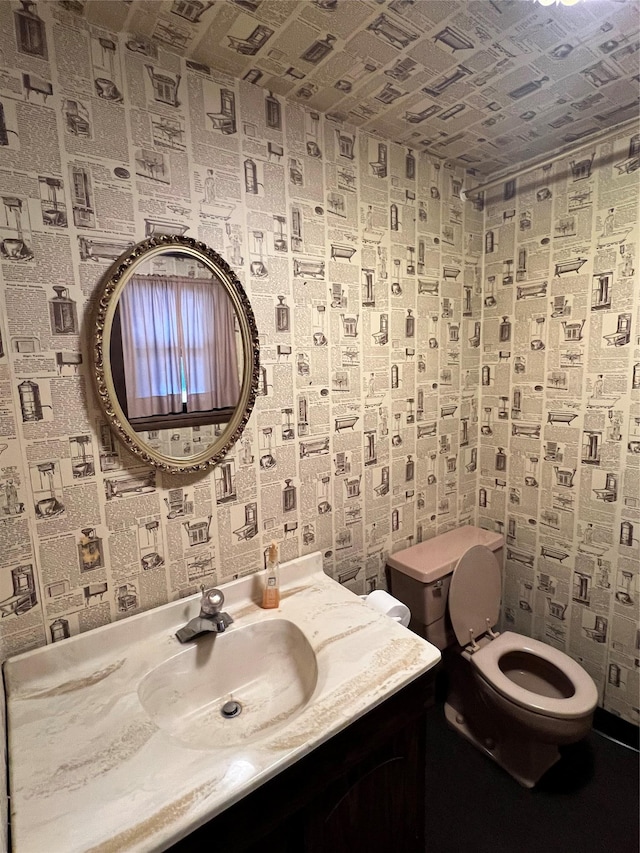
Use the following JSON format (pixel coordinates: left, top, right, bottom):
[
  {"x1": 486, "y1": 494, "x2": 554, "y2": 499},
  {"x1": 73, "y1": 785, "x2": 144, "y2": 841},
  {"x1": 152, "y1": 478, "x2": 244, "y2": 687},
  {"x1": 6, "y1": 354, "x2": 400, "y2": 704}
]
[{"x1": 387, "y1": 524, "x2": 504, "y2": 583}]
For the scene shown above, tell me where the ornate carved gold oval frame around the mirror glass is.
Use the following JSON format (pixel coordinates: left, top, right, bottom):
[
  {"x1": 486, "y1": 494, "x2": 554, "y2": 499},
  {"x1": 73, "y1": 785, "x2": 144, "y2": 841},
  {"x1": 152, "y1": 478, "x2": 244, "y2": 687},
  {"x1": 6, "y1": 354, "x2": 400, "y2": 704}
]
[{"x1": 91, "y1": 235, "x2": 260, "y2": 473}]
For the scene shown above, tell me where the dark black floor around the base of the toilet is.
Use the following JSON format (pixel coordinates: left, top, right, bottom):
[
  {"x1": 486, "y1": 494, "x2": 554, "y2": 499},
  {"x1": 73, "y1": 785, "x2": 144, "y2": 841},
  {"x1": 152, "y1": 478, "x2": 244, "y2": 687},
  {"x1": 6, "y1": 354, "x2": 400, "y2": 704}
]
[{"x1": 427, "y1": 703, "x2": 640, "y2": 853}]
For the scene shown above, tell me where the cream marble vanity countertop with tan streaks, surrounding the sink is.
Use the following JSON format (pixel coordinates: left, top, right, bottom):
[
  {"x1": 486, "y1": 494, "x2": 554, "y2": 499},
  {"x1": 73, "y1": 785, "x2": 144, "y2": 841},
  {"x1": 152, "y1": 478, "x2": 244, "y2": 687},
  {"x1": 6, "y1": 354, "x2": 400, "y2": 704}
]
[{"x1": 5, "y1": 553, "x2": 440, "y2": 853}]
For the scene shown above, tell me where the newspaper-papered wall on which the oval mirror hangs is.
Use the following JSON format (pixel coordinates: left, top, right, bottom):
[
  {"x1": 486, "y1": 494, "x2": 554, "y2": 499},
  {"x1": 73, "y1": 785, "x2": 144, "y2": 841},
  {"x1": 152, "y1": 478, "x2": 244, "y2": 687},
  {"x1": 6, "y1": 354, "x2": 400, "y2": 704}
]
[{"x1": 0, "y1": 4, "x2": 482, "y2": 654}]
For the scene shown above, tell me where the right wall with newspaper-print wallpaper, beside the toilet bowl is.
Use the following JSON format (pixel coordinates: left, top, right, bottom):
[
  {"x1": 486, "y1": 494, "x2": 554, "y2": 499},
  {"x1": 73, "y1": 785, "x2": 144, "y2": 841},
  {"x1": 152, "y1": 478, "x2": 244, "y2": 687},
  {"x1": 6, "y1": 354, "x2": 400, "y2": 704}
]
[{"x1": 478, "y1": 133, "x2": 640, "y2": 724}]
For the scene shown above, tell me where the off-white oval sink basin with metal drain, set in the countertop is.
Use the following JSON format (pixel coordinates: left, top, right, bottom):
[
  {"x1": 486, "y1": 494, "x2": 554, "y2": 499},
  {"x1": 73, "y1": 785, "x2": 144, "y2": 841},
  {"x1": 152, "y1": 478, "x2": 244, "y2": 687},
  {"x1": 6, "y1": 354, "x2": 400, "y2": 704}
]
[{"x1": 138, "y1": 619, "x2": 318, "y2": 749}]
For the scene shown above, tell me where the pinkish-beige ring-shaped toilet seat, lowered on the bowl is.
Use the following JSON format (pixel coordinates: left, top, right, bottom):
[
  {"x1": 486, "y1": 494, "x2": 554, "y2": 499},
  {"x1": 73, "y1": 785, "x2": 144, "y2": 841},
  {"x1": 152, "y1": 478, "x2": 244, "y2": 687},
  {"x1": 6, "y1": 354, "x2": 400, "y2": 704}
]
[{"x1": 471, "y1": 631, "x2": 598, "y2": 719}]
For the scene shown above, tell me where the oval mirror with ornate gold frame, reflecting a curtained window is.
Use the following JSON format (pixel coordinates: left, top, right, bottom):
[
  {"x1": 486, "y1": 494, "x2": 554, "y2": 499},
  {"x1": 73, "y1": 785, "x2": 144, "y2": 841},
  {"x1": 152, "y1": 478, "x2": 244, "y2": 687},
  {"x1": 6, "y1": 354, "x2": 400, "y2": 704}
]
[{"x1": 91, "y1": 235, "x2": 259, "y2": 473}]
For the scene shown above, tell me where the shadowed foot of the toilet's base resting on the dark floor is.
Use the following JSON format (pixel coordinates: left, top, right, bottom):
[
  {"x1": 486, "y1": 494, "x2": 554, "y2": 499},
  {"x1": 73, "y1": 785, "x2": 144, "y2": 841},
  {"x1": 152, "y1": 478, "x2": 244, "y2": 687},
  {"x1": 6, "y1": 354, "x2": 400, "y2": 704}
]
[{"x1": 444, "y1": 702, "x2": 560, "y2": 788}]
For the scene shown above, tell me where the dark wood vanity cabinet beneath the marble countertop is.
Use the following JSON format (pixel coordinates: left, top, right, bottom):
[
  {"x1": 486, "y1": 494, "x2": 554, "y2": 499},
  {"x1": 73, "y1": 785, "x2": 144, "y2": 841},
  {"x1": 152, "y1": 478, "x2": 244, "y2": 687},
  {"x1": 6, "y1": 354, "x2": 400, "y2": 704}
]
[{"x1": 170, "y1": 673, "x2": 433, "y2": 853}]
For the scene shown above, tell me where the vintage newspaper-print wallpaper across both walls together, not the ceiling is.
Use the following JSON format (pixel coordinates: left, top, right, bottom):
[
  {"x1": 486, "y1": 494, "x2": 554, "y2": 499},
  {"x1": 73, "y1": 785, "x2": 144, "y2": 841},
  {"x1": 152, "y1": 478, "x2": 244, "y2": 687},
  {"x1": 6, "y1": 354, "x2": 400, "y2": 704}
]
[{"x1": 0, "y1": 3, "x2": 640, "y2": 723}]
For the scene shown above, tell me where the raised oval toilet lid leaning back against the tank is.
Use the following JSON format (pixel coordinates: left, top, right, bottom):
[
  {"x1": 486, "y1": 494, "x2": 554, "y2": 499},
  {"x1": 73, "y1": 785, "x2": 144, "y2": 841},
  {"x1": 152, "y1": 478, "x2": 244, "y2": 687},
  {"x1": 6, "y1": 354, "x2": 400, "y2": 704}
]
[{"x1": 449, "y1": 545, "x2": 501, "y2": 646}]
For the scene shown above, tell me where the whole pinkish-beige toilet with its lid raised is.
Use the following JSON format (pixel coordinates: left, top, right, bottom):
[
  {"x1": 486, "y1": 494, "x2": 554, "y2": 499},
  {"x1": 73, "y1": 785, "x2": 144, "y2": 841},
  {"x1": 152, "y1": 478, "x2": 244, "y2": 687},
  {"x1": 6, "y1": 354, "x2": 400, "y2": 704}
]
[{"x1": 387, "y1": 526, "x2": 598, "y2": 788}]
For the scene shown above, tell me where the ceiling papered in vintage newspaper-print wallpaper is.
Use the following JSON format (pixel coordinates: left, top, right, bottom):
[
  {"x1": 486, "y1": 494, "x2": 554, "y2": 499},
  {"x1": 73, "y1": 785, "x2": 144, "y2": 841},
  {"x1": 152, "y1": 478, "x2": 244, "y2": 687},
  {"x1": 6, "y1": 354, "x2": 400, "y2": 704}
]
[{"x1": 89, "y1": 0, "x2": 640, "y2": 175}]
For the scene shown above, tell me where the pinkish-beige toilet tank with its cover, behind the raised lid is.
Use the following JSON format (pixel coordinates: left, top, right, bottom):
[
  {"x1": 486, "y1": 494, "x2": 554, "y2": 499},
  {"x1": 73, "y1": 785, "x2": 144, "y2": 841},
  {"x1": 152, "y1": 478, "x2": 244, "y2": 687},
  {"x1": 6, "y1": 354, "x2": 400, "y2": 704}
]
[{"x1": 387, "y1": 525, "x2": 504, "y2": 649}]
